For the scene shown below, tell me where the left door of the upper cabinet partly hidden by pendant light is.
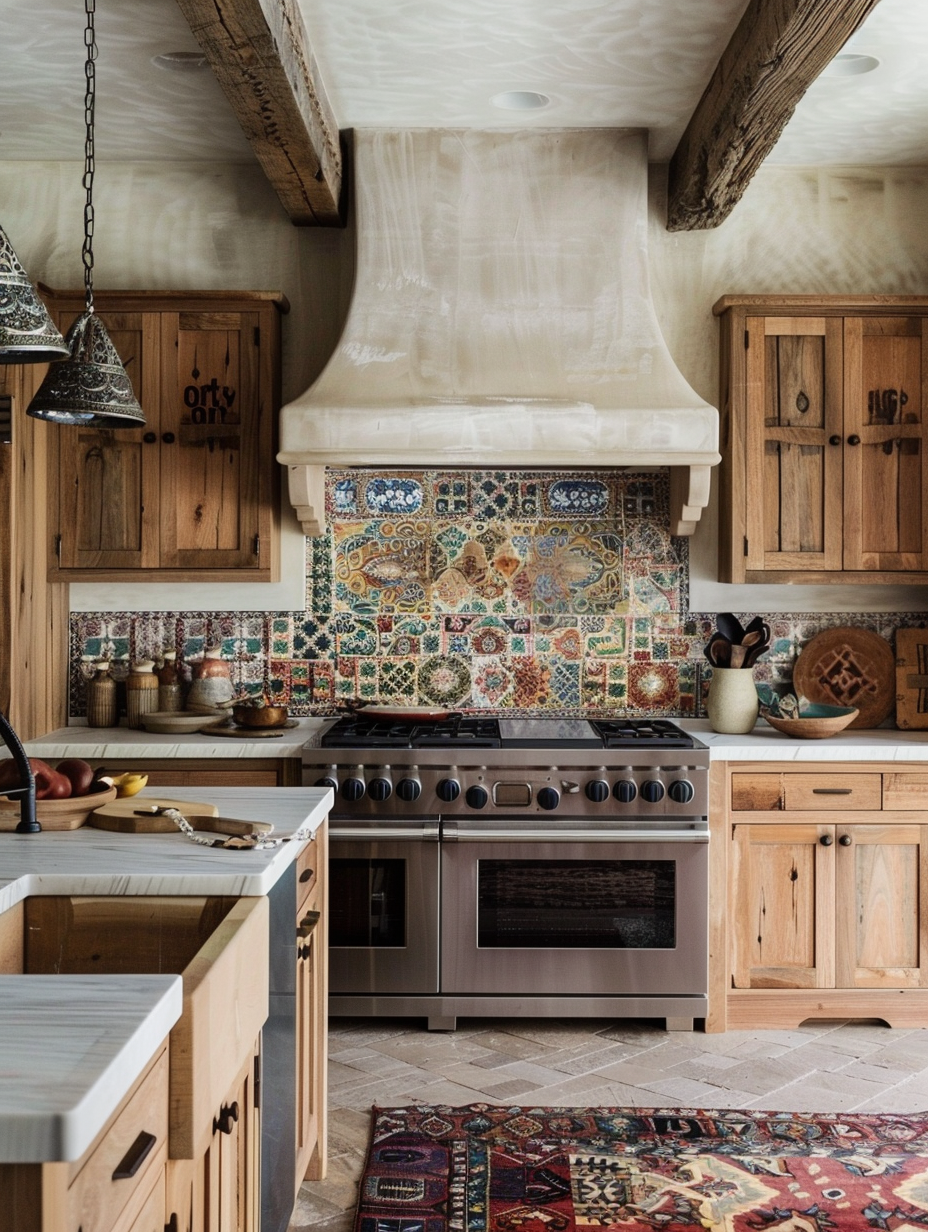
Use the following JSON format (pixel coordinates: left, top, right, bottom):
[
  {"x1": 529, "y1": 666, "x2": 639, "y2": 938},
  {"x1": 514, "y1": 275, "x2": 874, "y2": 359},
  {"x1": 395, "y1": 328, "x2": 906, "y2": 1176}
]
[{"x1": 49, "y1": 312, "x2": 161, "y2": 570}]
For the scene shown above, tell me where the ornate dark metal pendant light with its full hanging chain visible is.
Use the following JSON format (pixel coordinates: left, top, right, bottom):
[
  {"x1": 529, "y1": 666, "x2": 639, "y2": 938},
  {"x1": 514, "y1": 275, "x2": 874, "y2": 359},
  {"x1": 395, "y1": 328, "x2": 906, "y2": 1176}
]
[{"x1": 26, "y1": 0, "x2": 145, "y2": 428}]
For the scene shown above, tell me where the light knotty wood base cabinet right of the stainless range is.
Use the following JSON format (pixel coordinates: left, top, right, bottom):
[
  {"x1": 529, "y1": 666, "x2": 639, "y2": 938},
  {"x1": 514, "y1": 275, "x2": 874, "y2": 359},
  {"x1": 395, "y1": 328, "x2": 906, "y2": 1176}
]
[{"x1": 706, "y1": 763, "x2": 928, "y2": 1030}]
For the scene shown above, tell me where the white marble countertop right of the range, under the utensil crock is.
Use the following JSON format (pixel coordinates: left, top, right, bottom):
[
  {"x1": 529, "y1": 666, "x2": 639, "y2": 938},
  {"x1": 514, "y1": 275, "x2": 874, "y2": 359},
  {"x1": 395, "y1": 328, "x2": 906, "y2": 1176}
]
[{"x1": 679, "y1": 718, "x2": 928, "y2": 761}]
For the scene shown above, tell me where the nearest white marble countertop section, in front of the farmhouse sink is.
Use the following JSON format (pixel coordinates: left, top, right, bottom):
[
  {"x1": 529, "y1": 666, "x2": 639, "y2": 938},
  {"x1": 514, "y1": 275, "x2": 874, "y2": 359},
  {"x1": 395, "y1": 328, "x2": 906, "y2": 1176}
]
[{"x1": 0, "y1": 976, "x2": 182, "y2": 1163}]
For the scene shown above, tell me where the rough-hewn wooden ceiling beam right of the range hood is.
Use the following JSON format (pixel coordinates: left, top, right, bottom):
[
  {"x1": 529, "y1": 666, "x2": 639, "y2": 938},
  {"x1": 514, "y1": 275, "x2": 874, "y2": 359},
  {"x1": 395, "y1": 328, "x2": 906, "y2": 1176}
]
[{"x1": 667, "y1": 0, "x2": 879, "y2": 230}]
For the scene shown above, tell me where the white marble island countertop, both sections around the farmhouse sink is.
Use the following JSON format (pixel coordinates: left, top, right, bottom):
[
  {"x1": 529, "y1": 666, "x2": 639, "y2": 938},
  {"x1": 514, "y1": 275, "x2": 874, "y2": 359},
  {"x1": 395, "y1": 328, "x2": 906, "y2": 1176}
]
[{"x1": 0, "y1": 787, "x2": 333, "y2": 1163}]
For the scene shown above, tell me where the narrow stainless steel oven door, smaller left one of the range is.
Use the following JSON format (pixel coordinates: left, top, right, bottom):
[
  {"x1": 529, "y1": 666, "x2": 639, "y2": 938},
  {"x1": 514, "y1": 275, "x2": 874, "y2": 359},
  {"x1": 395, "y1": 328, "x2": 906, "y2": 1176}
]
[{"x1": 329, "y1": 821, "x2": 439, "y2": 994}]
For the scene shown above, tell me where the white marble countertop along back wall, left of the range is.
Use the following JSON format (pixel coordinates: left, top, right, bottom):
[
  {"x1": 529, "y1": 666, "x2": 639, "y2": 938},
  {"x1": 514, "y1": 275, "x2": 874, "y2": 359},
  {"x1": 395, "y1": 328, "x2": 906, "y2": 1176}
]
[{"x1": 0, "y1": 718, "x2": 330, "y2": 761}]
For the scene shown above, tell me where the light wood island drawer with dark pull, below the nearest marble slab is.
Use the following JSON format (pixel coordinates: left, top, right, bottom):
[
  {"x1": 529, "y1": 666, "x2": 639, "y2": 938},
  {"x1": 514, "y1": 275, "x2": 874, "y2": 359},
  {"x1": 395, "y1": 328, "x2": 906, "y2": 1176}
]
[{"x1": 68, "y1": 1048, "x2": 169, "y2": 1232}]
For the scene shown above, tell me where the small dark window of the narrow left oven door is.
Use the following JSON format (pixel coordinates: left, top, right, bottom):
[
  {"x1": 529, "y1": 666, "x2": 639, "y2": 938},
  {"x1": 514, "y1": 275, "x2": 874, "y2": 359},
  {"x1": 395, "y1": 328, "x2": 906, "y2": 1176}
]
[{"x1": 329, "y1": 859, "x2": 407, "y2": 949}]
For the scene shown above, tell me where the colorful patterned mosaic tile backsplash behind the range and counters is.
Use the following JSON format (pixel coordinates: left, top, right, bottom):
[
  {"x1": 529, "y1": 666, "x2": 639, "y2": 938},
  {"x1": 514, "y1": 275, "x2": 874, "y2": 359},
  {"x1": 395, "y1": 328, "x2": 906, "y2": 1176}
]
[{"x1": 70, "y1": 471, "x2": 926, "y2": 717}]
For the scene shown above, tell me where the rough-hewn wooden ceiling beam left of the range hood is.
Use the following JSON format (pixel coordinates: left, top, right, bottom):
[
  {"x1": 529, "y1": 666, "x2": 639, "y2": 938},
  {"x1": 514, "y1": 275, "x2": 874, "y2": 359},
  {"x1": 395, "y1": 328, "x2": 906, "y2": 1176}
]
[{"x1": 177, "y1": 0, "x2": 344, "y2": 227}]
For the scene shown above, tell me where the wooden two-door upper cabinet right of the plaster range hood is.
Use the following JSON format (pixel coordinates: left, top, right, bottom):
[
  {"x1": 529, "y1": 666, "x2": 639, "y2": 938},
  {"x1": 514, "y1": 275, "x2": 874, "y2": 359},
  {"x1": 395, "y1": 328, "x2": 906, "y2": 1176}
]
[{"x1": 714, "y1": 296, "x2": 928, "y2": 583}]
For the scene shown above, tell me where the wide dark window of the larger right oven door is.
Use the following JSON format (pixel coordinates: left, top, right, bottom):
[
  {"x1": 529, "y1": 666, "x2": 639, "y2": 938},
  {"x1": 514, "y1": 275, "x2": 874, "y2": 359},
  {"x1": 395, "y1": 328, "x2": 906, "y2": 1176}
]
[{"x1": 477, "y1": 860, "x2": 677, "y2": 950}]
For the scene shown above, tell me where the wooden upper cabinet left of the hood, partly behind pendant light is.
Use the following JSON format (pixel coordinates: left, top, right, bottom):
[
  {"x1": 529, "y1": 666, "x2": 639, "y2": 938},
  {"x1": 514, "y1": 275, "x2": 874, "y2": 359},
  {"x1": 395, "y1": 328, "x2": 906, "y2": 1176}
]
[{"x1": 49, "y1": 292, "x2": 286, "y2": 582}]
